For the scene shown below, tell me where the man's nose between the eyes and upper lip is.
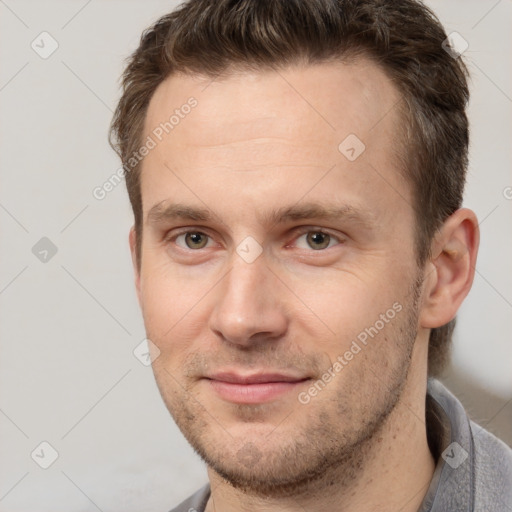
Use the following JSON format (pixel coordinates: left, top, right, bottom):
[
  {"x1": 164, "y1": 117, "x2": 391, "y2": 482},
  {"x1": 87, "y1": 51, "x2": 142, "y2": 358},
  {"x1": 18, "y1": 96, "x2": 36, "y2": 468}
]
[{"x1": 210, "y1": 254, "x2": 288, "y2": 346}]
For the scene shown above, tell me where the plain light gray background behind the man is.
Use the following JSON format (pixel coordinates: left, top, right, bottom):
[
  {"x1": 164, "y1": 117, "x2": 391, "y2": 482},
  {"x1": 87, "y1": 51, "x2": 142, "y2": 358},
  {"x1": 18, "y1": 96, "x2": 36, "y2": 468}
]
[{"x1": 0, "y1": 0, "x2": 512, "y2": 512}]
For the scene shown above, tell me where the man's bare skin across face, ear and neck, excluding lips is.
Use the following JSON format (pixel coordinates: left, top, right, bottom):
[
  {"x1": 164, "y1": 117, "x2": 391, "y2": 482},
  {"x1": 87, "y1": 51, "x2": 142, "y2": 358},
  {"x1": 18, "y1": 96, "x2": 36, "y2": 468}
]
[{"x1": 130, "y1": 60, "x2": 478, "y2": 512}]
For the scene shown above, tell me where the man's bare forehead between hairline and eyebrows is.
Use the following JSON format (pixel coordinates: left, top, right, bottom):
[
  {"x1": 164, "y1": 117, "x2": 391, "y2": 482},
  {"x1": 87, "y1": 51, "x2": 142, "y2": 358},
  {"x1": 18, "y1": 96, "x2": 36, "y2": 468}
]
[{"x1": 141, "y1": 59, "x2": 407, "y2": 226}]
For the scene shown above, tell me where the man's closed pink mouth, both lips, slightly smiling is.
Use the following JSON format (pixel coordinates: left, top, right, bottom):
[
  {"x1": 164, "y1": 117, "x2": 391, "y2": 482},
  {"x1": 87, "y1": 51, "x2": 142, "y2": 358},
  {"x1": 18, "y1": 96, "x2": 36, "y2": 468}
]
[{"x1": 204, "y1": 372, "x2": 311, "y2": 404}]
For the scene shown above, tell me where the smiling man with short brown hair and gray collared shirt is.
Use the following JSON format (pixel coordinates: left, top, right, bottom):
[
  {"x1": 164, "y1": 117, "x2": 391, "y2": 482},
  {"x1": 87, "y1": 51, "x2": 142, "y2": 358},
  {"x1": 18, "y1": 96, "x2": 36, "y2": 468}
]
[{"x1": 112, "y1": 0, "x2": 512, "y2": 512}]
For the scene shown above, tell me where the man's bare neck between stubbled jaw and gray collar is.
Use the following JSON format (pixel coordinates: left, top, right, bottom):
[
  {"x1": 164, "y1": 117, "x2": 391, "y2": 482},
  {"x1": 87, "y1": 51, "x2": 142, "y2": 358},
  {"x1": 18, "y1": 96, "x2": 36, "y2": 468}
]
[{"x1": 206, "y1": 348, "x2": 435, "y2": 512}]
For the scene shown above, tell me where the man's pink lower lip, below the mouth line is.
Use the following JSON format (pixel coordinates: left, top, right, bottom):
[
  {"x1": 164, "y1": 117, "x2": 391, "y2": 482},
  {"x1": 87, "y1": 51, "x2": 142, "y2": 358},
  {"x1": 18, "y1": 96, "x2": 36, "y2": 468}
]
[{"x1": 208, "y1": 379, "x2": 305, "y2": 404}]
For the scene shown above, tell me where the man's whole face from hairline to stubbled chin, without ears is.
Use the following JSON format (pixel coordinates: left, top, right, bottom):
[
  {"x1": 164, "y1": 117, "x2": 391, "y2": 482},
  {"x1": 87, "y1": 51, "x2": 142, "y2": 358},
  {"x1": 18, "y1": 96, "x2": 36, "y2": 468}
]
[{"x1": 138, "y1": 61, "x2": 419, "y2": 492}]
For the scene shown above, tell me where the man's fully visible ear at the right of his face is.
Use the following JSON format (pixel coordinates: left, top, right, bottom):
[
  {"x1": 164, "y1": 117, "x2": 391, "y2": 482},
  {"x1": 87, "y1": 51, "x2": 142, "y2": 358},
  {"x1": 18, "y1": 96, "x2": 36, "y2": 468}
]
[{"x1": 420, "y1": 208, "x2": 480, "y2": 329}]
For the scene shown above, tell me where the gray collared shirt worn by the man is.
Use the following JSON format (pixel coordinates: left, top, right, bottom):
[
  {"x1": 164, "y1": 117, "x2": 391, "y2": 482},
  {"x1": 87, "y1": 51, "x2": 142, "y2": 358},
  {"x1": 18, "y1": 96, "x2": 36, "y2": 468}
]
[{"x1": 171, "y1": 379, "x2": 512, "y2": 512}]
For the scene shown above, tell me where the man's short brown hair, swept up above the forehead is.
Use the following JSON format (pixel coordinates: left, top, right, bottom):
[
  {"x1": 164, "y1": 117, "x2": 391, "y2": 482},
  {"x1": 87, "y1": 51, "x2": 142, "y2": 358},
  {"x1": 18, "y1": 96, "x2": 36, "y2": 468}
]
[{"x1": 110, "y1": 0, "x2": 469, "y2": 375}]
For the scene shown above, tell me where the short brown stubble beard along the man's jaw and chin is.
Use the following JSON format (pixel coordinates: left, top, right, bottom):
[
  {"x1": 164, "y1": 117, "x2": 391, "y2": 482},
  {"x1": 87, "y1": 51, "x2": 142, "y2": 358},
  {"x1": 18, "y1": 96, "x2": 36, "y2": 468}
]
[{"x1": 153, "y1": 276, "x2": 422, "y2": 498}]
